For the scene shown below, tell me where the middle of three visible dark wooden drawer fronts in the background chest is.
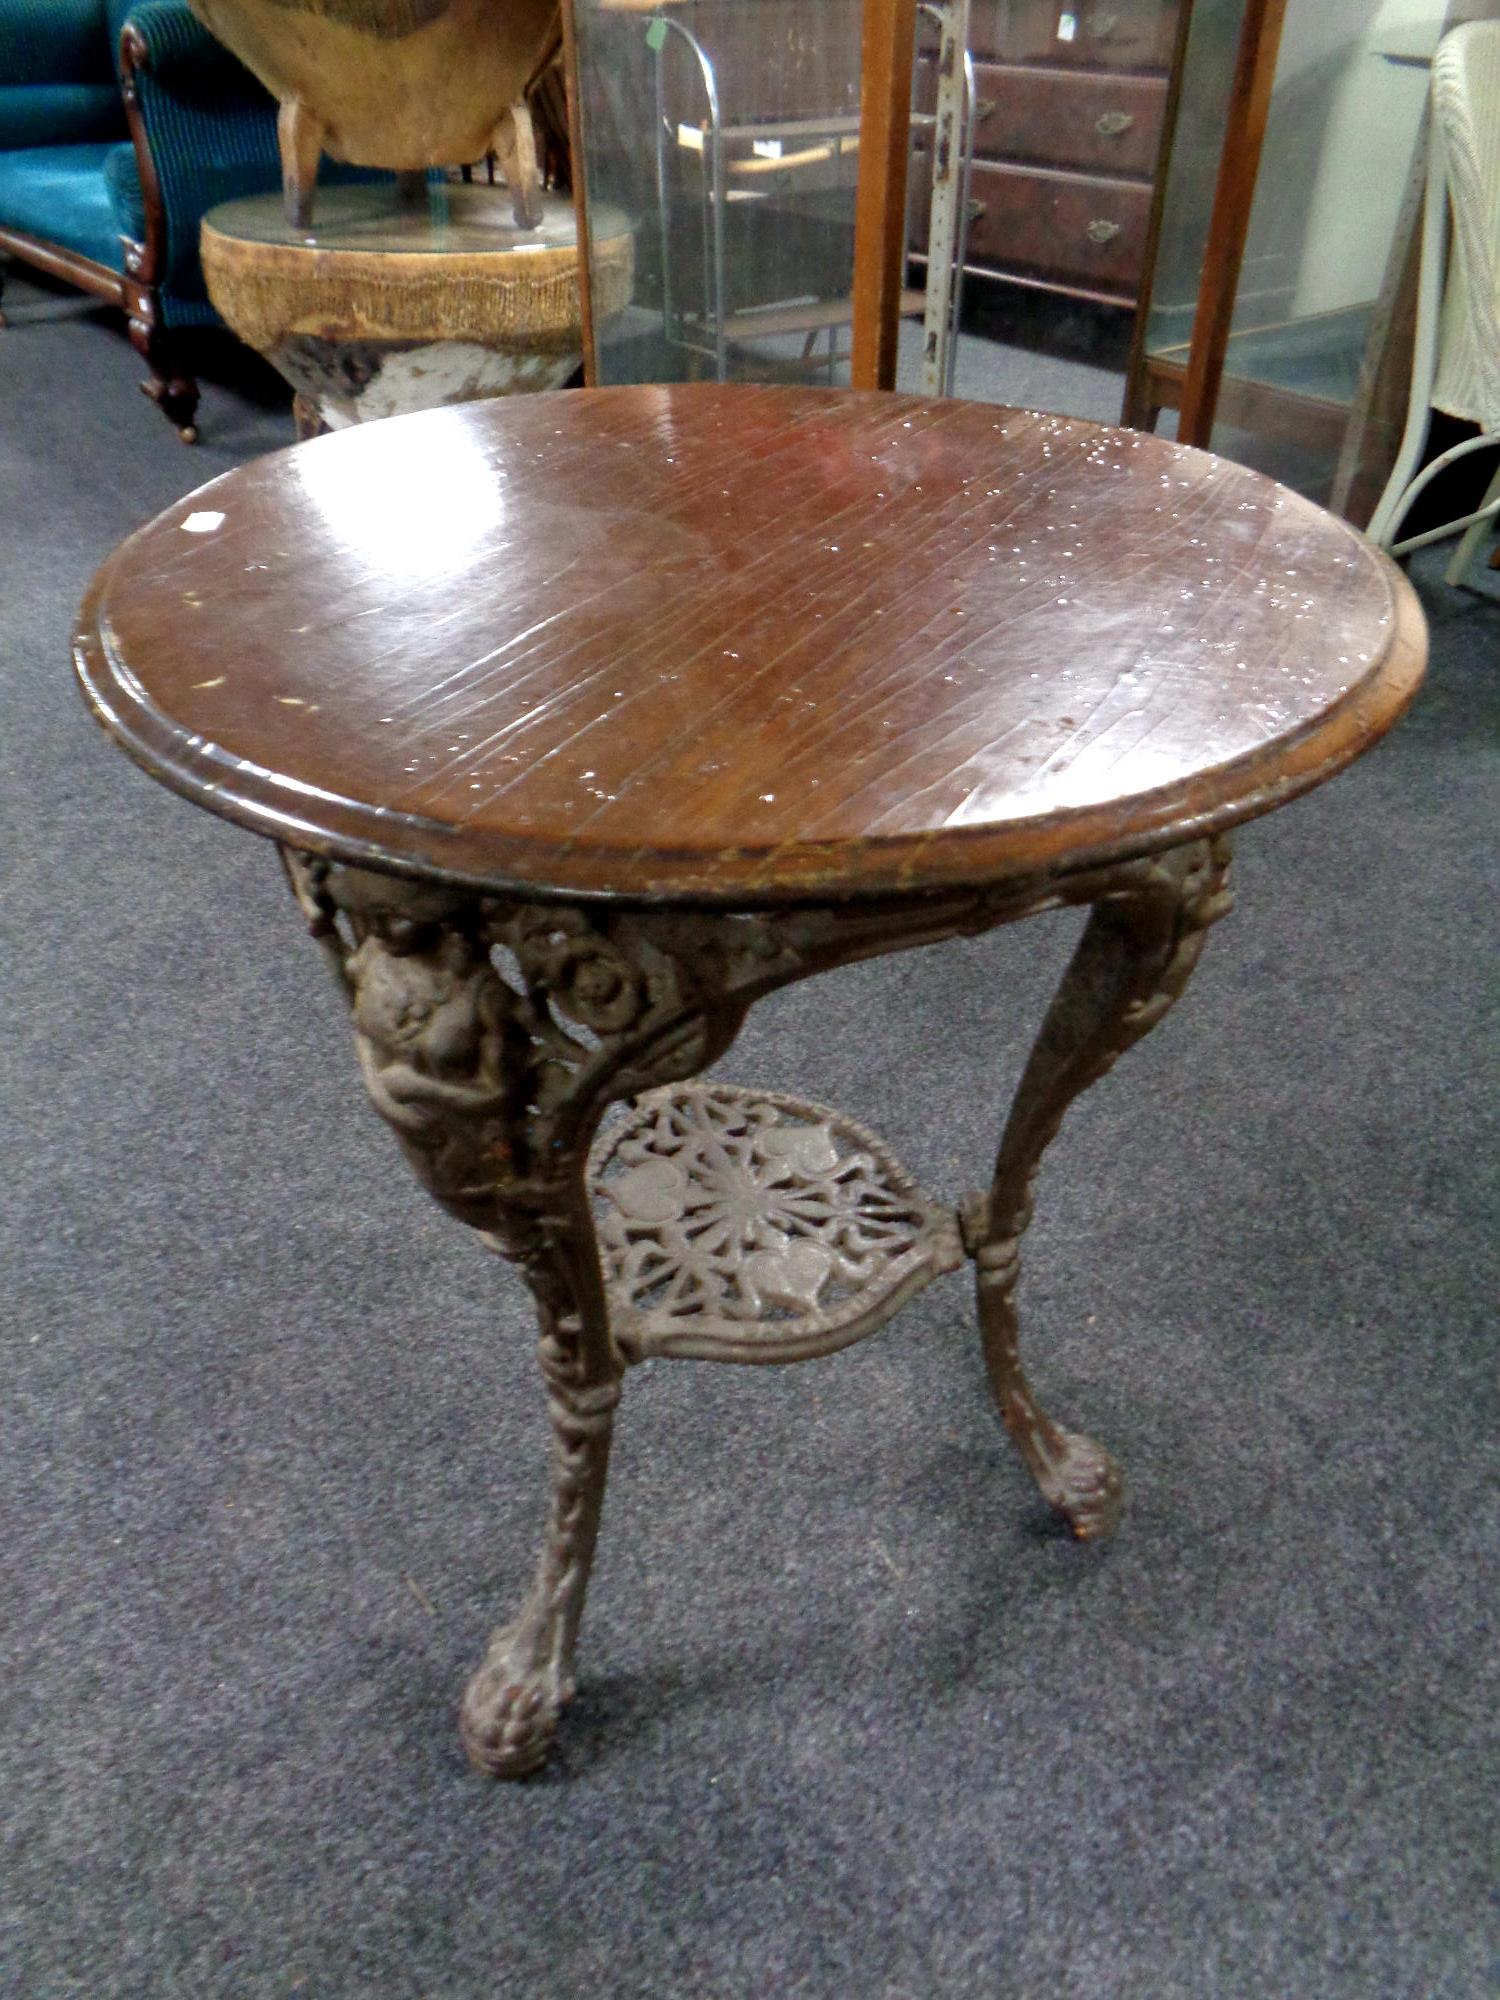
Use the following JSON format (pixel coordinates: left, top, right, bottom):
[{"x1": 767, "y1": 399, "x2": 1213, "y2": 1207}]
[{"x1": 974, "y1": 62, "x2": 1166, "y2": 178}]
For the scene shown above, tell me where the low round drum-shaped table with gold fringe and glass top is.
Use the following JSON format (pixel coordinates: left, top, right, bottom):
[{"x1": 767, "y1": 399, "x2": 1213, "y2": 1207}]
[{"x1": 202, "y1": 182, "x2": 634, "y2": 432}]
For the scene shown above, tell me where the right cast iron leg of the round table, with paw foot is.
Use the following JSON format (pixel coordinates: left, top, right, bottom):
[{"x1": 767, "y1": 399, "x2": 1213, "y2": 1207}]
[{"x1": 964, "y1": 840, "x2": 1230, "y2": 1540}]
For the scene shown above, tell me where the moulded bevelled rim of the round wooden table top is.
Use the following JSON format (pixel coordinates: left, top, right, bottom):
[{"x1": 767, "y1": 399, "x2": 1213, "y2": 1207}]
[{"x1": 72, "y1": 438, "x2": 1428, "y2": 908}]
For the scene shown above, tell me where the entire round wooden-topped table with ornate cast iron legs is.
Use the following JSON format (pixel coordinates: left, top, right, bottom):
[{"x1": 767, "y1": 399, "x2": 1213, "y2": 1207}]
[{"x1": 76, "y1": 388, "x2": 1424, "y2": 1776}]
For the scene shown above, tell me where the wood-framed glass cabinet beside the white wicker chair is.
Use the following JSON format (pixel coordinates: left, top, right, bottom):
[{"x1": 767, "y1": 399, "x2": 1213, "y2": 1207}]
[{"x1": 1126, "y1": 0, "x2": 1490, "y2": 506}]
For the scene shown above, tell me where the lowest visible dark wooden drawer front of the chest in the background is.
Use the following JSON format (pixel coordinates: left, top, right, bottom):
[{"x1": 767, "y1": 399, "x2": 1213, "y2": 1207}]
[{"x1": 968, "y1": 160, "x2": 1152, "y2": 298}]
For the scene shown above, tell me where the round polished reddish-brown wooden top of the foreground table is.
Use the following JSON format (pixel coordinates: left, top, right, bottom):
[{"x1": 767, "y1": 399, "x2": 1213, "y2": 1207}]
[{"x1": 76, "y1": 386, "x2": 1426, "y2": 906}]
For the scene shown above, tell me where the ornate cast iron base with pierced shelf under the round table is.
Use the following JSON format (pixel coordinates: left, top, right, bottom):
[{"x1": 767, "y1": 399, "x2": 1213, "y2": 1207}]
[{"x1": 282, "y1": 838, "x2": 1230, "y2": 1778}]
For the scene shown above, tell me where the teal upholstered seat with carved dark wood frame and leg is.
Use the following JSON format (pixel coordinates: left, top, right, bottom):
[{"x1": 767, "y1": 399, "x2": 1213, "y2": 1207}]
[{"x1": 0, "y1": 0, "x2": 280, "y2": 440}]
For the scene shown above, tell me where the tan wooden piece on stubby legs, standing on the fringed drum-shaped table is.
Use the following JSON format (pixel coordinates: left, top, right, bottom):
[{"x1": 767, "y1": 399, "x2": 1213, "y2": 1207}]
[{"x1": 190, "y1": 0, "x2": 560, "y2": 228}]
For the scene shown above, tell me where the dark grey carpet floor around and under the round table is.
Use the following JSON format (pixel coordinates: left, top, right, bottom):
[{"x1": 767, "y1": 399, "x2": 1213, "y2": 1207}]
[{"x1": 0, "y1": 280, "x2": 1500, "y2": 2000}]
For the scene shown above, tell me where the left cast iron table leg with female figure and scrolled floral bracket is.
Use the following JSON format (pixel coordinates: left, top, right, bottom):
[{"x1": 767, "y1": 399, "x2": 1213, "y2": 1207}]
[{"x1": 284, "y1": 854, "x2": 764, "y2": 1778}]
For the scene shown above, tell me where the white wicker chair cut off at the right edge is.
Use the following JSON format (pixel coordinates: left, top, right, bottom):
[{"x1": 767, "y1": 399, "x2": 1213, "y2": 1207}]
[{"x1": 1366, "y1": 20, "x2": 1500, "y2": 584}]
